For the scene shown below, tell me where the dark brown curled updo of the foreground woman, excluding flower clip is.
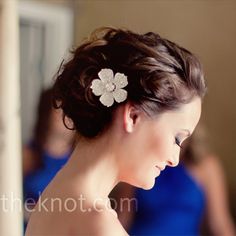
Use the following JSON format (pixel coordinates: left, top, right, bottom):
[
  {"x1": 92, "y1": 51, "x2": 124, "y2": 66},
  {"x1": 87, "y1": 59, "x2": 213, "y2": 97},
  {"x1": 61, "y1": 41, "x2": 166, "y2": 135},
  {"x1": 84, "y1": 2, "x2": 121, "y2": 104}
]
[{"x1": 54, "y1": 28, "x2": 206, "y2": 138}]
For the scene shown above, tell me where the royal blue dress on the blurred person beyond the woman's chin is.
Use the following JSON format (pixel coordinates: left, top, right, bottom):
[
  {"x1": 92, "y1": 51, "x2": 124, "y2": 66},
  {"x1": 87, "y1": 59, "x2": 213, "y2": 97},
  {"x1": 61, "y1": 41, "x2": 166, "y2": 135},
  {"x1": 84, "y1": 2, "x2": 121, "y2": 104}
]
[{"x1": 129, "y1": 164, "x2": 205, "y2": 236}]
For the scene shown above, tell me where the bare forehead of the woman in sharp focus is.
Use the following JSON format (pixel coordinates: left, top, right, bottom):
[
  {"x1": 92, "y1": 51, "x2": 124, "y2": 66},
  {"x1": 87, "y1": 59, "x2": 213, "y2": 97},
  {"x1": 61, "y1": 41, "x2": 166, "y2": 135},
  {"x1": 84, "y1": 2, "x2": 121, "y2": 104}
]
[{"x1": 154, "y1": 97, "x2": 201, "y2": 133}]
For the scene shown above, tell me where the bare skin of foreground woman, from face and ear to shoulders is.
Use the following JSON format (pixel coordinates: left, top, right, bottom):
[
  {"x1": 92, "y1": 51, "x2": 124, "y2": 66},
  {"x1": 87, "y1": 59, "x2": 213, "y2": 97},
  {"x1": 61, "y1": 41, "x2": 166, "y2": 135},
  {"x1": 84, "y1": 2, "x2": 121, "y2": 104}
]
[{"x1": 26, "y1": 97, "x2": 201, "y2": 236}]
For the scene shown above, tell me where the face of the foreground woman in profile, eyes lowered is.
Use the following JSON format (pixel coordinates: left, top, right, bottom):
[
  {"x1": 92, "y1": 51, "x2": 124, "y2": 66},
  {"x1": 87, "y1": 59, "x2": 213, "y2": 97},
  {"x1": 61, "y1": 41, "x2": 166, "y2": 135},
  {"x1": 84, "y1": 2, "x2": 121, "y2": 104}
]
[{"x1": 121, "y1": 97, "x2": 201, "y2": 189}]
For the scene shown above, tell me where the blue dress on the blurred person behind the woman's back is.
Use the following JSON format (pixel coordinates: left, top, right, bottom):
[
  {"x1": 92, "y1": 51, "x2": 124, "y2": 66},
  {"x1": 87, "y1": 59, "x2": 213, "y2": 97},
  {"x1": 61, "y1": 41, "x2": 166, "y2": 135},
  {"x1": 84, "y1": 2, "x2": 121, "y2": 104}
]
[{"x1": 24, "y1": 151, "x2": 71, "y2": 201}]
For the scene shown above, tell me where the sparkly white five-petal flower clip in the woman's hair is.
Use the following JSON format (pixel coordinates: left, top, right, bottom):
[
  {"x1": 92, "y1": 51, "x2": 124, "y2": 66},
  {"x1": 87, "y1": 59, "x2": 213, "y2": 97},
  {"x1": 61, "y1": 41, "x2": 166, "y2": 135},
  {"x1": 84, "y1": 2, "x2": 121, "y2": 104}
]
[{"x1": 90, "y1": 68, "x2": 128, "y2": 107}]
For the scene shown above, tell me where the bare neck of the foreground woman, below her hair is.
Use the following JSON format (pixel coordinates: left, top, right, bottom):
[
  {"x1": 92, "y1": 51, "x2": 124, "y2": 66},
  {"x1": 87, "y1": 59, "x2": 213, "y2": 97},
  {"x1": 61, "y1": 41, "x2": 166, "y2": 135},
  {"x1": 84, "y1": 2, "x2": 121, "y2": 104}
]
[{"x1": 64, "y1": 136, "x2": 119, "y2": 201}]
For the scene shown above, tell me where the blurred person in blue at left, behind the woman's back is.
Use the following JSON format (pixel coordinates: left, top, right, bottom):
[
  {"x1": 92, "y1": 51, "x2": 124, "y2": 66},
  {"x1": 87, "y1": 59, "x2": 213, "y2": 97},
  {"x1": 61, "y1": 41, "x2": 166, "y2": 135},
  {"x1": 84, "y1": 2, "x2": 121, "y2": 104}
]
[{"x1": 23, "y1": 88, "x2": 75, "y2": 223}]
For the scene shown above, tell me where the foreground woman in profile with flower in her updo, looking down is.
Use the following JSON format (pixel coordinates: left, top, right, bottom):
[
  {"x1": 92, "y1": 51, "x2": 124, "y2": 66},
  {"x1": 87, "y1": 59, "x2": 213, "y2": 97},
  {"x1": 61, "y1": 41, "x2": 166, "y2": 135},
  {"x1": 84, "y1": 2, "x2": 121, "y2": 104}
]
[{"x1": 26, "y1": 28, "x2": 206, "y2": 235}]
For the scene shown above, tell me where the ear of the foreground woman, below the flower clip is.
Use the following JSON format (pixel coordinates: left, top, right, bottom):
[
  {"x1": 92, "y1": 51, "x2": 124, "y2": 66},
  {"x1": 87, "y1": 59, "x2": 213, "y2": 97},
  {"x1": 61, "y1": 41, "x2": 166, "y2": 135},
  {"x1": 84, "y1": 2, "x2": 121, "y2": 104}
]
[{"x1": 123, "y1": 103, "x2": 142, "y2": 133}]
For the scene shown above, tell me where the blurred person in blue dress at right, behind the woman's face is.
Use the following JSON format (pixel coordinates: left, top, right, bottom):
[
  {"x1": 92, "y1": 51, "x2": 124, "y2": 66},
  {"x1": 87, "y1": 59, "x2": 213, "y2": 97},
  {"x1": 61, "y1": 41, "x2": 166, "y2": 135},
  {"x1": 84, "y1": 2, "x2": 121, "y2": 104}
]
[{"x1": 111, "y1": 126, "x2": 236, "y2": 236}]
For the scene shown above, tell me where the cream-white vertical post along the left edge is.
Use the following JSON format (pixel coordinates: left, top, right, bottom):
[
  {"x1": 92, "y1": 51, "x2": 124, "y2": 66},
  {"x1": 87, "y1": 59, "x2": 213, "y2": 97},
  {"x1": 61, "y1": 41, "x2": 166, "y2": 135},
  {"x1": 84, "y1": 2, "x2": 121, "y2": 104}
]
[{"x1": 0, "y1": 0, "x2": 23, "y2": 236}]
